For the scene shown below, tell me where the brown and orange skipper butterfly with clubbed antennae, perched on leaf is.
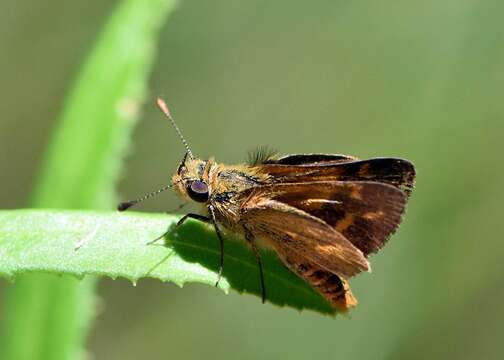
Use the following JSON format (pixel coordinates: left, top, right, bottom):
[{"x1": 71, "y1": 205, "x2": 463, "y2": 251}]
[{"x1": 118, "y1": 99, "x2": 415, "y2": 311}]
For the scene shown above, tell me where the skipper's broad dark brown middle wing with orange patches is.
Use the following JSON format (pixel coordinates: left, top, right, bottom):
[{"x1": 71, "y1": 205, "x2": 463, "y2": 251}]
[{"x1": 250, "y1": 181, "x2": 407, "y2": 256}]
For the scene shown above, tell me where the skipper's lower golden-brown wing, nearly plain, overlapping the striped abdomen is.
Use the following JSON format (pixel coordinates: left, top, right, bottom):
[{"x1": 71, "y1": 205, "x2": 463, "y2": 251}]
[{"x1": 241, "y1": 195, "x2": 369, "y2": 276}]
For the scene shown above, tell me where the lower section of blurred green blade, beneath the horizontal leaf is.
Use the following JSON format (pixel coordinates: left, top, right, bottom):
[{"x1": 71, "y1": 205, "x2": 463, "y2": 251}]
[{"x1": 2, "y1": 274, "x2": 95, "y2": 360}]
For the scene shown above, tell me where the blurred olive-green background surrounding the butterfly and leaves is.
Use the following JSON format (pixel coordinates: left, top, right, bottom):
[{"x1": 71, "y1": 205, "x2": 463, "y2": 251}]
[{"x1": 0, "y1": 0, "x2": 504, "y2": 359}]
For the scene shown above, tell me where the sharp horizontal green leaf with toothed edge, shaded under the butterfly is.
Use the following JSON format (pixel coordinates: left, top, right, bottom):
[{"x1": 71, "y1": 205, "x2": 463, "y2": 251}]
[{"x1": 0, "y1": 210, "x2": 333, "y2": 314}]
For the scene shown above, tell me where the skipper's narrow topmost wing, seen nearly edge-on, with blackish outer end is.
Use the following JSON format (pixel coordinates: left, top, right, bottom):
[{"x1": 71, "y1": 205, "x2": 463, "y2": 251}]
[{"x1": 261, "y1": 158, "x2": 415, "y2": 195}]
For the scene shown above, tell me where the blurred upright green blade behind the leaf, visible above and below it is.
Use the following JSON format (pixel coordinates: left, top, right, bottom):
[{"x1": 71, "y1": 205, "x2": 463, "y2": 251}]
[{"x1": 0, "y1": 0, "x2": 175, "y2": 360}]
